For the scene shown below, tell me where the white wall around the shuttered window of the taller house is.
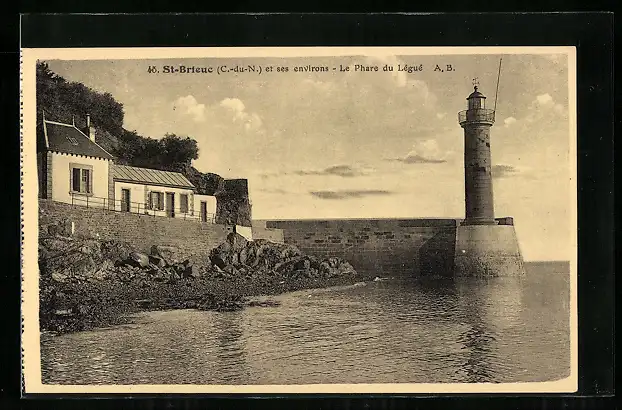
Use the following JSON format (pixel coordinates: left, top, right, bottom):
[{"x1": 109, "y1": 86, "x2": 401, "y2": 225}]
[{"x1": 48, "y1": 152, "x2": 110, "y2": 206}]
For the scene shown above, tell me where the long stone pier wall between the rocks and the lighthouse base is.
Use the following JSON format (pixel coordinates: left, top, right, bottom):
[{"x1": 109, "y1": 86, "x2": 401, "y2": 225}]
[{"x1": 256, "y1": 219, "x2": 459, "y2": 276}]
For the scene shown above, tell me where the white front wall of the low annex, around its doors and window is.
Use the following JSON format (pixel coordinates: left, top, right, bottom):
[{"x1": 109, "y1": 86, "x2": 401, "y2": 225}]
[{"x1": 114, "y1": 181, "x2": 198, "y2": 219}]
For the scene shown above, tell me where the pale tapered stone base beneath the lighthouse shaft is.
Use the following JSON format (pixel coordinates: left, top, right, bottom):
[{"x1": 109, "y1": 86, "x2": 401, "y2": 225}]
[{"x1": 454, "y1": 224, "x2": 525, "y2": 277}]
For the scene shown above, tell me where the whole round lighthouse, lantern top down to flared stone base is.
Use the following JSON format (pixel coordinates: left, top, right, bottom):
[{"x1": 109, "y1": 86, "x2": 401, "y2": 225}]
[{"x1": 454, "y1": 80, "x2": 525, "y2": 276}]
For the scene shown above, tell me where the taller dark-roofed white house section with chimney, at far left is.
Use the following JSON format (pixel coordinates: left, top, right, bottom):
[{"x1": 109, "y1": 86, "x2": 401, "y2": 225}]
[{"x1": 37, "y1": 116, "x2": 113, "y2": 206}]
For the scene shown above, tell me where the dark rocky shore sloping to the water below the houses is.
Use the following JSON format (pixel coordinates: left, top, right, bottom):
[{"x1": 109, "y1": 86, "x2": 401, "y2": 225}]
[{"x1": 39, "y1": 232, "x2": 366, "y2": 333}]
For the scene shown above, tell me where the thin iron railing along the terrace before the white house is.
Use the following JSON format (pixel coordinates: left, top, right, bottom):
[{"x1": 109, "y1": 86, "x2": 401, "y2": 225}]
[{"x1": 70, "y1": 193, "x2": 216, "y2": 224}]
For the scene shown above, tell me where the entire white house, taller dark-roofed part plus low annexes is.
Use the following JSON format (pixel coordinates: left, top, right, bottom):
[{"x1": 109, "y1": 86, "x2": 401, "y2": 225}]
[{"x1": 37, "y1": 116, "x2": 216, "y2": 223}]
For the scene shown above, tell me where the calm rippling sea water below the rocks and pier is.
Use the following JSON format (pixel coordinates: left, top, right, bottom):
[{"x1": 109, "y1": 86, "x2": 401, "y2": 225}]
[{"x1": 41, "y1": 264, "x2": 570, "y2": 384}]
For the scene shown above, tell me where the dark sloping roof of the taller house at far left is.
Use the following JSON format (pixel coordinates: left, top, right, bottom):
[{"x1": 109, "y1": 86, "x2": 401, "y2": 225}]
[{"x1": 41, "y1": 120, "x2": 114, "y2": 160}]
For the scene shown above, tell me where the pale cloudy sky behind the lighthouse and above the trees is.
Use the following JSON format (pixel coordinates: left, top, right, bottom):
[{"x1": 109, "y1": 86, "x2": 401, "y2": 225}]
[{"x1": 48, "y1": 54, "x2": 573, "y2": 260}]
